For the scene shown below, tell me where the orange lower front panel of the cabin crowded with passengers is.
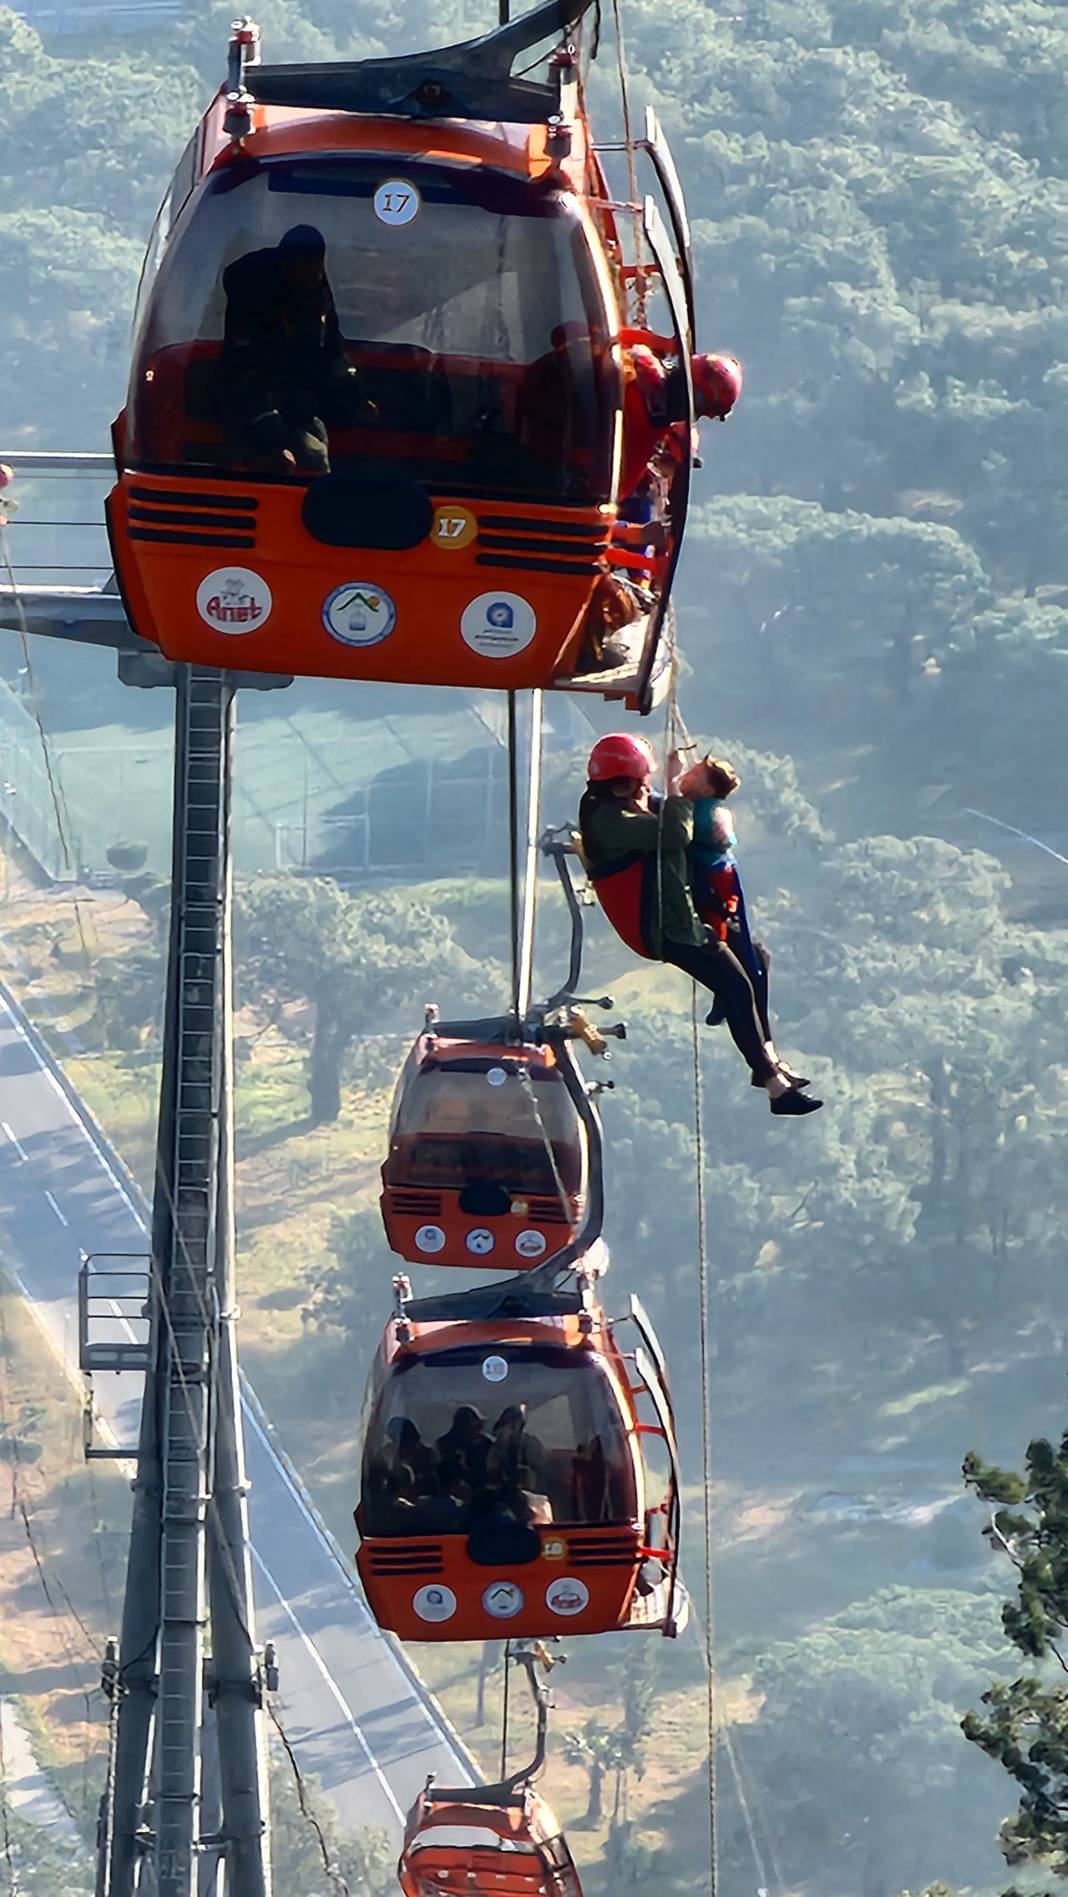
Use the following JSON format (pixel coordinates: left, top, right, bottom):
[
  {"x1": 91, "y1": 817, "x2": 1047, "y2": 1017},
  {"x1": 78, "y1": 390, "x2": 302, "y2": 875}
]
[{"x1": 357, "y1": 1525, "x2": 639, "y2": 1641}]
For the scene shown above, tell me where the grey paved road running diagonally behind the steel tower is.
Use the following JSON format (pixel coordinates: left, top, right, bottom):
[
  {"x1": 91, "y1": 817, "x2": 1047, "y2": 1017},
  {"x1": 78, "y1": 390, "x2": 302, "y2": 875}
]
[{"x1": 0, "y1": 986, "x2": 470, "y2": 1838}]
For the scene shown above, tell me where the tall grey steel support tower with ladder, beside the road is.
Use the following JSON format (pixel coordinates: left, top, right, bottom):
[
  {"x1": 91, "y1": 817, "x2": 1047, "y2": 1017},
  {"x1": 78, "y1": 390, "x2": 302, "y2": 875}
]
[{"x1": 75, "y1": 666, "x2": 271, "y2": 1897}]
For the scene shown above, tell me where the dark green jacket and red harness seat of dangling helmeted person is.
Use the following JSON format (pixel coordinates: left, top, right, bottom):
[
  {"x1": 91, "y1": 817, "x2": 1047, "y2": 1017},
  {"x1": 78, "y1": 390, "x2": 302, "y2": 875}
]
[{"x1": 579, "y1": 785, "x2": 706, "y2": 960}]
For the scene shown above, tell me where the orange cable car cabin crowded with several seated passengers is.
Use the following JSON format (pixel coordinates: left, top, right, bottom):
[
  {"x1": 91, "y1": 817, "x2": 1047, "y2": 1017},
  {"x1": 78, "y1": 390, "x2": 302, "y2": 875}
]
[{"x1": 355, "y1": 1273, "x2": 685, "y2": 1641}]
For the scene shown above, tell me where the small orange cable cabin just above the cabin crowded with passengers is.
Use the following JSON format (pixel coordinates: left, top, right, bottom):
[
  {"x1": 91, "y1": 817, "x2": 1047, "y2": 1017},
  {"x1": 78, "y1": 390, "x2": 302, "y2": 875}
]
[{"x1": 379, "y1": 1021, "x2": 592, "y2": 1271}]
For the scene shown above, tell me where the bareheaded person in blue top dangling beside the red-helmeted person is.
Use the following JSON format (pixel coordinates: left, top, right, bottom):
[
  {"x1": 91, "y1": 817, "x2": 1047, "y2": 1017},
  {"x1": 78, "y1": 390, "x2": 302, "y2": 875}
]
[{"x1": 677, "y1": 755, "x2": 808, "y2": 1087}]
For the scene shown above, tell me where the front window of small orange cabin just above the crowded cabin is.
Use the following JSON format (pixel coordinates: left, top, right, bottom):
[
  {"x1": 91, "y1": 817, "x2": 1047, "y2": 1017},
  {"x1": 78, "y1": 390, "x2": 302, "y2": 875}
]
[{"x1": 387, "y1": 1059, "x2": 586, "y2": 1197}]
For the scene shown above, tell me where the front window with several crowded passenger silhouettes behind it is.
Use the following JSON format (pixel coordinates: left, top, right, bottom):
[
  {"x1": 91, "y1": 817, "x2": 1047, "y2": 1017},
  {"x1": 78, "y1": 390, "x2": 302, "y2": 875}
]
[{"x1": 368, "y1": 1345, "x2": 637, "y2": 1537}]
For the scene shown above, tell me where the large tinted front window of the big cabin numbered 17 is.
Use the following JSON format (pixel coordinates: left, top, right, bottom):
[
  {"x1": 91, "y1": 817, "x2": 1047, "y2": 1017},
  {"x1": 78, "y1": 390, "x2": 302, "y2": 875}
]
[{"x1": 129, "y1": 159, "x2": 620, "y2": 501}]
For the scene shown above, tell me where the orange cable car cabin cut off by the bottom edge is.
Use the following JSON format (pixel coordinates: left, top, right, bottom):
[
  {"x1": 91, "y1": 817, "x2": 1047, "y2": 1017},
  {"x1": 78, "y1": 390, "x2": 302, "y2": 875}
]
[{"x1": 396, "y1": 1785, "x2": 582, "y2": 1897}]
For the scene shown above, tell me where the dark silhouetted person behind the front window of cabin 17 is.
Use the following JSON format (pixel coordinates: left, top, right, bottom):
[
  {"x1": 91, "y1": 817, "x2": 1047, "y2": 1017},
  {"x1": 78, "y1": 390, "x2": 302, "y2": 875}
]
[{"x1": 220, "y1": 224, "x2": 374, "y2": 474}]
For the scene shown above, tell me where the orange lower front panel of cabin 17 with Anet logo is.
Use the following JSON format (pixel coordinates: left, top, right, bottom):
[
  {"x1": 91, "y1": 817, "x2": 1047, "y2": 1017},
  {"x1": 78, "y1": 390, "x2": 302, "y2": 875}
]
[{"x1": 108, "y1": 470, "x2": 611, "y2": 691}]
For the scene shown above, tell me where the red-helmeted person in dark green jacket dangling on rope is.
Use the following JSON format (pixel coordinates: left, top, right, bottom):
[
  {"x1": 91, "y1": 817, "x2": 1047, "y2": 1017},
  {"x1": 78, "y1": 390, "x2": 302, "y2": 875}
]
[{"x1": 579, "y1": 732, "x2": 823, "y2": 1115}]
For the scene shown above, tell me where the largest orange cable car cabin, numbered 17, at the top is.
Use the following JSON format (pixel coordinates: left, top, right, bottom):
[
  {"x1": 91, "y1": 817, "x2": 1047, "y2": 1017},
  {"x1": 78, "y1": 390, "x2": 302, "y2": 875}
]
[{"x1": 108, "y1": 0, "x2": 692, "y2": 709}]
